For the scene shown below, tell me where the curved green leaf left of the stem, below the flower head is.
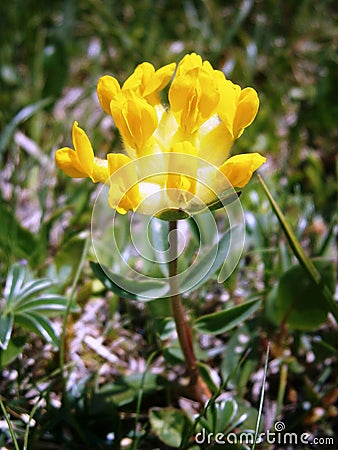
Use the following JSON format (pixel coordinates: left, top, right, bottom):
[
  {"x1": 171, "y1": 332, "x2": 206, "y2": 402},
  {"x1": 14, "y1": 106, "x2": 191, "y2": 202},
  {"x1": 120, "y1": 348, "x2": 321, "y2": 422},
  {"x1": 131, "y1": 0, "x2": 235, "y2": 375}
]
[{"x1": 90, "y1": 261, "x2": 169, "y2": 301}]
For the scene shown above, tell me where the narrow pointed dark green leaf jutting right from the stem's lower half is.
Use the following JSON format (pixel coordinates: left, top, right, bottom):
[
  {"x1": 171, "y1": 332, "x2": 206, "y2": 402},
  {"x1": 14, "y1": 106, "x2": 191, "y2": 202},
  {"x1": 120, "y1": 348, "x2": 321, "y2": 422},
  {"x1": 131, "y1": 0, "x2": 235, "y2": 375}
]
[{"x1": 193, "y1": 299, "x2": 260, "y2": 334}]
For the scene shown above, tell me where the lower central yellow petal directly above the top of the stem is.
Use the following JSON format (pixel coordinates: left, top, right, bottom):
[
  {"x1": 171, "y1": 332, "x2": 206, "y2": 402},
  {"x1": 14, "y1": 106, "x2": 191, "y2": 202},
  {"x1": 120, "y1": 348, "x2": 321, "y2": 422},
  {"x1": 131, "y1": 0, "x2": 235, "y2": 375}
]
[{"x1": 166, "y1": 141, "x2": 198, "y2": 204}]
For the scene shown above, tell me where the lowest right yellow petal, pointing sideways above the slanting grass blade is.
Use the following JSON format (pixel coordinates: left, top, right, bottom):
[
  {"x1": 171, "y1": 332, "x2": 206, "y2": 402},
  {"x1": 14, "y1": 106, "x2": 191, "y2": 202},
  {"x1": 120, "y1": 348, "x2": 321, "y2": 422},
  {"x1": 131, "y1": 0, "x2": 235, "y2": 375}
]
[{"x1": 219, "y1": 153, "x2": 266, "y2": 188}]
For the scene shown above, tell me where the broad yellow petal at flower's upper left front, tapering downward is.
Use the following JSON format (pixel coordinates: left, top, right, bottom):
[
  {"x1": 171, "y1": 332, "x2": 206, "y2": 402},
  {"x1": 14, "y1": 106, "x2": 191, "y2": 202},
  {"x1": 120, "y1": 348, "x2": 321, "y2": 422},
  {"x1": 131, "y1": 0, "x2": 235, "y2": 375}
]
[{"x1": 110, "y1": 91, "x2": 157, "y2": 156}]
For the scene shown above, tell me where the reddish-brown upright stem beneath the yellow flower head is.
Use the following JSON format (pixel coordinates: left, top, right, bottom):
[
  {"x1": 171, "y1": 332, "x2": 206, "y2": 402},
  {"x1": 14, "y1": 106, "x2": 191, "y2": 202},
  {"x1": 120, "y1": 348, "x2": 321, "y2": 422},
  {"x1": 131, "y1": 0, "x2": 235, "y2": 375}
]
[{"x1": 169, "y1": 220, "x2": 212, "y2": 405}]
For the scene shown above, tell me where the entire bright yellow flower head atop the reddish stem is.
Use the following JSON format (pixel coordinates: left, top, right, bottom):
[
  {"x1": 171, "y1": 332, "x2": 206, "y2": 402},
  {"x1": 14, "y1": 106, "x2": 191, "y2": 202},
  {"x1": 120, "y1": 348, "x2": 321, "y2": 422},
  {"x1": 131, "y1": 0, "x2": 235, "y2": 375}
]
[{"x1": 55, "y1": 53, "x2": 266, "y2": 220}]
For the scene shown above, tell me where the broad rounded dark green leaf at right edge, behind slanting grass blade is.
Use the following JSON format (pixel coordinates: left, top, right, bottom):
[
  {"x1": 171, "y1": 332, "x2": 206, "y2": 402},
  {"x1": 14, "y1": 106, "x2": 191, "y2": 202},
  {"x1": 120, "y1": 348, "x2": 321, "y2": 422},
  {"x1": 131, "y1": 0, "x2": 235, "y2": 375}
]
[{"x1": 271, "y1": 260, "x2": 335, "y2": 330}]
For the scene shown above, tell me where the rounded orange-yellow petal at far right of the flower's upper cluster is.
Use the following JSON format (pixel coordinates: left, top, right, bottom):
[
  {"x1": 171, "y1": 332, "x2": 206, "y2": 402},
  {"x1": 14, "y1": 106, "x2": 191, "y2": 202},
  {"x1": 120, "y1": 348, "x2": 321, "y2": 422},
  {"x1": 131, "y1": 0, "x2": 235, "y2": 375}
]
[{"x1": 233, "y1": 88, "x2": 259, "y2": 139}]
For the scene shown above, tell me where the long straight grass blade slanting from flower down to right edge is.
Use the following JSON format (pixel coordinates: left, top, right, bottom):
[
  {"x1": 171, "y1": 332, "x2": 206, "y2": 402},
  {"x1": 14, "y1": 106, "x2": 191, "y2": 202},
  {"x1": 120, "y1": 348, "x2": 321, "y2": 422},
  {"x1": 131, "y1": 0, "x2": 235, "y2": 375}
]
[{"x1": 258, "y1": 174, "x2": 338, "y2": 322}]
